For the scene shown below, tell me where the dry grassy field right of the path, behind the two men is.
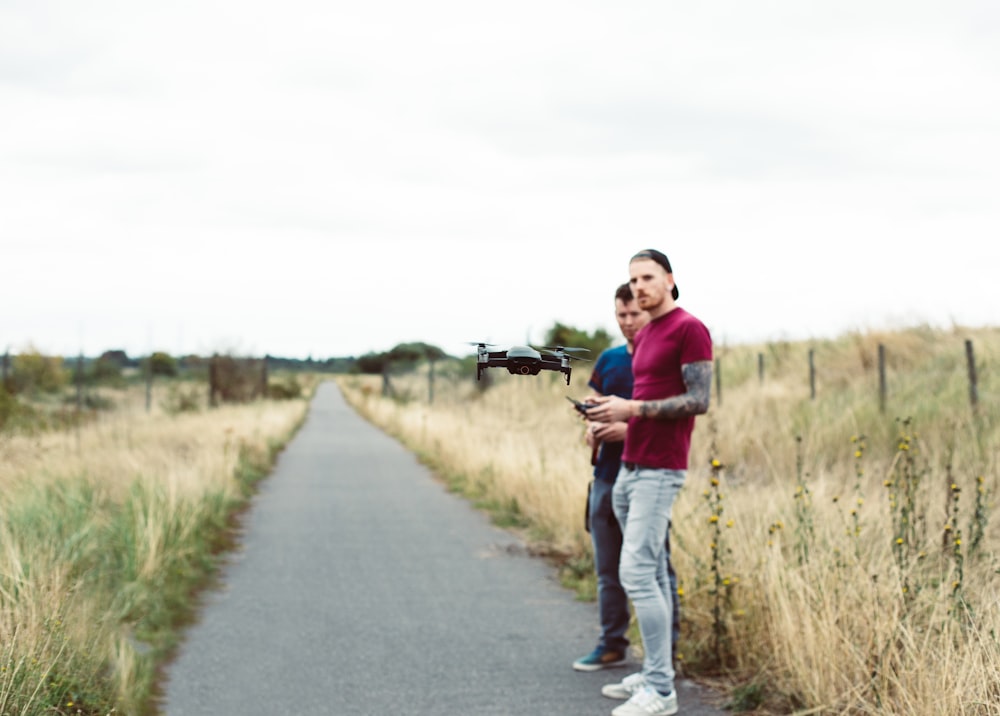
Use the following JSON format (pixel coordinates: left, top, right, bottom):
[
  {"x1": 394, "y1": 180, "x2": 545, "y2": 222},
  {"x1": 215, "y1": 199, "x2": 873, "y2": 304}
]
[{"x1": 338, "y1": 328, "x2": 1000, "y2": 716}]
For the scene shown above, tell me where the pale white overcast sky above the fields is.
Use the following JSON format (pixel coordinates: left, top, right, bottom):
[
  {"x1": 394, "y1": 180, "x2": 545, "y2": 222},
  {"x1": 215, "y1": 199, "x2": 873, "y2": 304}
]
[{"x1": 0, "y1": 0, "x2": 1000, "y2": 358}]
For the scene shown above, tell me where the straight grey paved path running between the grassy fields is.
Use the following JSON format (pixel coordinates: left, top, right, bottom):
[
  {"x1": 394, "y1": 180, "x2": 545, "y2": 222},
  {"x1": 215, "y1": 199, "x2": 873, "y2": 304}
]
[{"x1": 162, "y1": 383, "x2": 723, "y2": 716}]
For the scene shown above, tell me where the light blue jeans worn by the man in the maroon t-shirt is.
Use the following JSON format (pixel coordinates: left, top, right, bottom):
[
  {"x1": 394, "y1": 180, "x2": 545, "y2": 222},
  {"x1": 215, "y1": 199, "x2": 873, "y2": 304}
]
[{"x1": 612, "y1": 464, "x2": 687, "y2": 694}]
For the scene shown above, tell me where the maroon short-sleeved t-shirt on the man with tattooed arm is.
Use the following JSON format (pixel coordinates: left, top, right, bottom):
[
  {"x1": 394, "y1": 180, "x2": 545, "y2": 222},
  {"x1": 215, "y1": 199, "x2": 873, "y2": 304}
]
[{"x1": 622, "y1": 307, "x2": 712, "y2": 470}]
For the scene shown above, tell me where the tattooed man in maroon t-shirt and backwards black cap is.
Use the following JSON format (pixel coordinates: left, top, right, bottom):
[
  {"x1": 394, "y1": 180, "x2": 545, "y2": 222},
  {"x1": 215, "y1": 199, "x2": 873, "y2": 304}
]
[{"x1": 587, "y1": 249, "x2": 712, "y2": 716}]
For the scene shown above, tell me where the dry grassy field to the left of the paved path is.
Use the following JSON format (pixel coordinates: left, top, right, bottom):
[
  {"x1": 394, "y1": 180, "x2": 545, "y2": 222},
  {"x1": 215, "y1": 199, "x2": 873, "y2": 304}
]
[{"x1": 0, "y1": 383, "x2": 311, "y2": 716}]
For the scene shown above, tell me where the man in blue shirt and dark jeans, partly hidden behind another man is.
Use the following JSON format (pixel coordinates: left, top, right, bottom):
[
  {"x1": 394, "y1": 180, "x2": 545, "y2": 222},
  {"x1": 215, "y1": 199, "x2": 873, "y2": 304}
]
[{"x1": 573, "y1": 283, "x2": 680, "y2": 671}]
